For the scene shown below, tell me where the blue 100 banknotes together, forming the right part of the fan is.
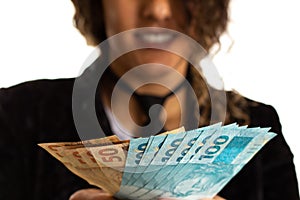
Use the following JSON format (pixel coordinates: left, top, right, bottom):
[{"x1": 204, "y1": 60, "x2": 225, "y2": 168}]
[{"x1": 116, "y1": 124, "x2": 276, "y2": 199}]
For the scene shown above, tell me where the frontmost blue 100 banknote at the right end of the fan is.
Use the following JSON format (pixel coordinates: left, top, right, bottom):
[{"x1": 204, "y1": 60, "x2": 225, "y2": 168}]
[{"x1": 155, "y1": 129, "x2": 275, "y2": 198}]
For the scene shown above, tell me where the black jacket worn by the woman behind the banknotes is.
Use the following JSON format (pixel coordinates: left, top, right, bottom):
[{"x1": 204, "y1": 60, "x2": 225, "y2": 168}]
[{"x1": 0, "y1": 79, "x2": 299, "y2": 200}]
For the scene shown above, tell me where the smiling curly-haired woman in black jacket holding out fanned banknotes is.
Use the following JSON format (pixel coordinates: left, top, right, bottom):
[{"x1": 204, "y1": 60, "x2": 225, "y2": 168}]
[{"x1": 0, "y1": 0, "x2": 299, "y2": 200}]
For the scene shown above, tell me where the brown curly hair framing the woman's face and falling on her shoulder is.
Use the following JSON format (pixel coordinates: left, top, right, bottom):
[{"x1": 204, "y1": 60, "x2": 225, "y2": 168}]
[{"x1": 72, "y1": 0, "x2": 250, "y2": 126}]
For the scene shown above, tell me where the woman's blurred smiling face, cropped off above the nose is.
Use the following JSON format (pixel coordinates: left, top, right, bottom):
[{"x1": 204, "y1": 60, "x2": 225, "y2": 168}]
[{"x1": 103, "y1": 0, "x2": 189, "y2": 81}]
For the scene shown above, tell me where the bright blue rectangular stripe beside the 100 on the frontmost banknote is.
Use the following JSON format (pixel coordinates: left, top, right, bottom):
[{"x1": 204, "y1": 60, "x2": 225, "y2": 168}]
[{"x1": 213, "y1": 136, "x2": 253, "y2": 164}]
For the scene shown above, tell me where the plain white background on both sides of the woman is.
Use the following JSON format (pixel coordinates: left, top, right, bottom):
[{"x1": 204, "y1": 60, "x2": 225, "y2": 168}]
[{"x1": 0, "y1": 0, "x2": 300, "y2": 189}]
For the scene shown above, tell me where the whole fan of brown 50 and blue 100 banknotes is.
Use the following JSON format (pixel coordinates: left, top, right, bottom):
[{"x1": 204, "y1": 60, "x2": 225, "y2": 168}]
[{"x1": 39, "y1": 124, "x2": 276, "y2": 199}]
